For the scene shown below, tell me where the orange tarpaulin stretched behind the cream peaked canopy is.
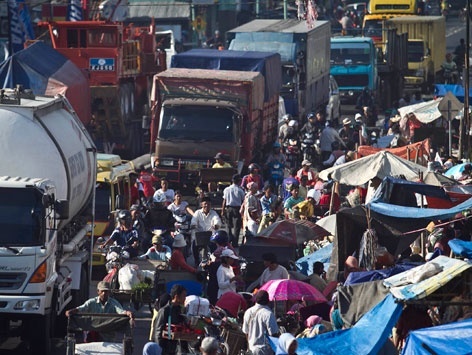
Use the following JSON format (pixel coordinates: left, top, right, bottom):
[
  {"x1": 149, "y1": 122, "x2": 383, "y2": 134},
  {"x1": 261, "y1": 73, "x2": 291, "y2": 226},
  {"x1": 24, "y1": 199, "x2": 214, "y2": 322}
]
[{"x1": 357, "y1": 139, "x2": 430, "y2": 166}]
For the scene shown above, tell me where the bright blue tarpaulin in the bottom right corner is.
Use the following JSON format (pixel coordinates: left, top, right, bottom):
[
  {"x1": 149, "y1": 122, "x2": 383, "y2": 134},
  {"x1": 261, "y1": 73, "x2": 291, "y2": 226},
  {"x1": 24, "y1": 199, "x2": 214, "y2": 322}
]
[{"x1": 402, "y1": 319, "x2": 472, "y2": 355}]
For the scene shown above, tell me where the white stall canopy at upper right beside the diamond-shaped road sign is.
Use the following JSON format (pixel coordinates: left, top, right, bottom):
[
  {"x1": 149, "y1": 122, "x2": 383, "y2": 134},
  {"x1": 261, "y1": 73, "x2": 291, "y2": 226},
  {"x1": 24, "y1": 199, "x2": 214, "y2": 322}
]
[{"x1": 398, "y1": 92, "x2": 464, "y2": 124}]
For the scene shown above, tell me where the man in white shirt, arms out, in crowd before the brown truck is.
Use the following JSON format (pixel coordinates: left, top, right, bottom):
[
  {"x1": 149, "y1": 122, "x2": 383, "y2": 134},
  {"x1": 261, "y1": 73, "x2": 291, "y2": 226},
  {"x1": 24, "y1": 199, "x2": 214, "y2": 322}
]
[{"x1": 190, "y1": 197, "x2": 222, "y2": 266}]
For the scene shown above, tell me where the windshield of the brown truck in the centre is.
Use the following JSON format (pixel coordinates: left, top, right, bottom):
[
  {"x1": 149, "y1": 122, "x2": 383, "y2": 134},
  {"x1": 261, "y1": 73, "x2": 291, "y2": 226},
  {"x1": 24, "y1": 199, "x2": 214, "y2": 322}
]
[{"x1": 158, "y1": 105, "x2": 236, "y2": 142}]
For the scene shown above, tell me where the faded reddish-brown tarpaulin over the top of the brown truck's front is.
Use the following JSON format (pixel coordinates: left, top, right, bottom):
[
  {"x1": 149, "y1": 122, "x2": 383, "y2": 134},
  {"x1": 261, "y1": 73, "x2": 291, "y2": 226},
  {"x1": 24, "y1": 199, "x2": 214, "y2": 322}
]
[{"x1": 156, "y1": 68, "x2": 264, "y2": 110}]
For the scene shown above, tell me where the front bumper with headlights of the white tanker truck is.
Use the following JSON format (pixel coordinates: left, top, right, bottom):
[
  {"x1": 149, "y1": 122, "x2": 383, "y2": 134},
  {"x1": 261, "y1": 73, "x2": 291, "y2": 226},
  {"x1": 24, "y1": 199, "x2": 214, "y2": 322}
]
[{"x1": 0, "y1": 295, "x2": 46, "y2": 319}]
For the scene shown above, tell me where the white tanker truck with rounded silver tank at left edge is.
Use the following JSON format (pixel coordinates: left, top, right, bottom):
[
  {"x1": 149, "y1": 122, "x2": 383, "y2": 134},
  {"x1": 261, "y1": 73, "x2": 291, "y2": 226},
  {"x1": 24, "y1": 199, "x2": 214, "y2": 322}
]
[{"x1": 0, "y1": 89, "x2": 96, "y2": 355}]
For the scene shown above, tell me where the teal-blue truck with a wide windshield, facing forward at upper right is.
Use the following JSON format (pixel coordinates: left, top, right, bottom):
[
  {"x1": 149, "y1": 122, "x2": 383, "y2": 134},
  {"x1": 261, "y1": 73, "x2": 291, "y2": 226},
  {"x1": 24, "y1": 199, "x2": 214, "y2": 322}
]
[{"x1": 330, "y1": 36, "x2": 379, "y2": 103}]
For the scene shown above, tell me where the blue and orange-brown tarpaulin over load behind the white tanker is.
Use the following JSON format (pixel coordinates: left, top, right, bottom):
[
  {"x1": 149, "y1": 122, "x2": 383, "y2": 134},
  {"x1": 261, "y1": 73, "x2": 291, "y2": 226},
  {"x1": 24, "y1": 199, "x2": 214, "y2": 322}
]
[{"x1": 0, "y1": 42, "x2": 90, "y2": 124}]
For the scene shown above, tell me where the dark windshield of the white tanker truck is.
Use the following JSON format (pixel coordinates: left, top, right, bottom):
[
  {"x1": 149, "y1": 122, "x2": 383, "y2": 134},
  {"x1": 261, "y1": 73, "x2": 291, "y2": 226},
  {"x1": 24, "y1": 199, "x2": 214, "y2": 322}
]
[{"x1": 0, "y1": 188, "x2": 45, "y2": 246}]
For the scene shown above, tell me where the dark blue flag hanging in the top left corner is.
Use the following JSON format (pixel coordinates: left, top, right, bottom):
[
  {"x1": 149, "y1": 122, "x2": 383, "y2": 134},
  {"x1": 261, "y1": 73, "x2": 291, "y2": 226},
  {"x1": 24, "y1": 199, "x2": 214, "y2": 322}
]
[{"x1": 8, "y1": 0, "x2": 34, "y2": 53}]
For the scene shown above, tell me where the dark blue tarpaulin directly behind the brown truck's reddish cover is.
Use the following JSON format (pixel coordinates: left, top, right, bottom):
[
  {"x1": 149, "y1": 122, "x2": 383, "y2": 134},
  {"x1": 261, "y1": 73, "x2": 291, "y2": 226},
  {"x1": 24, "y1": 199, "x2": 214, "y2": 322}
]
[{"x1": 171, "y1": 49, "x2": 282, "y2": 101}]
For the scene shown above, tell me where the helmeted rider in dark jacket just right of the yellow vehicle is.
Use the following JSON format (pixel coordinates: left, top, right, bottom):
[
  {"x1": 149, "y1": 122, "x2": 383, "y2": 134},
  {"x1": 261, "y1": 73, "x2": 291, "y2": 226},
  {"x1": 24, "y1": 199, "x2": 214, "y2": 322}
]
[{"x1": 101, "y1": 210, "x2": 139, "y2": 258}]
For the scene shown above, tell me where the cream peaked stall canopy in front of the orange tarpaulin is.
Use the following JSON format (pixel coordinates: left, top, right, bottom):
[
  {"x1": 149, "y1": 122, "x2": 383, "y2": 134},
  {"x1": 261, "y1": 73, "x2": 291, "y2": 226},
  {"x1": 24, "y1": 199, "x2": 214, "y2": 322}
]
[{"x1": 320, "y1": 151, "x2": 426, "y2": 186}]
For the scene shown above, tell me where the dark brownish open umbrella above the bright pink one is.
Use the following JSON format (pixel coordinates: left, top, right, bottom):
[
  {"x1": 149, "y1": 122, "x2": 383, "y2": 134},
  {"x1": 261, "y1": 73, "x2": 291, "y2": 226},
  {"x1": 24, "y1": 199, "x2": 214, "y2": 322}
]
[{"x1": 258, "y1": 219, "x2": 330, "y2": 245}]
